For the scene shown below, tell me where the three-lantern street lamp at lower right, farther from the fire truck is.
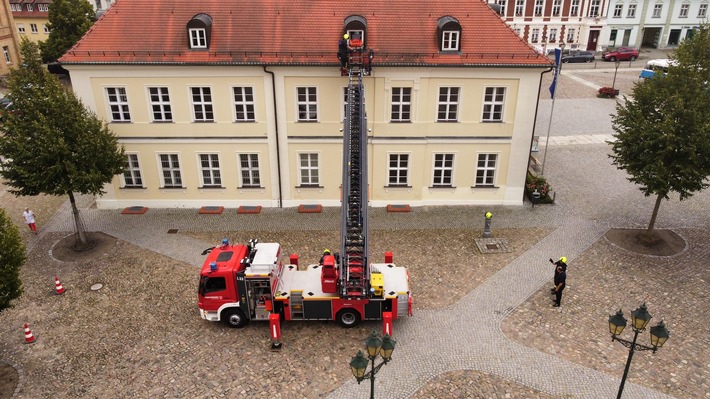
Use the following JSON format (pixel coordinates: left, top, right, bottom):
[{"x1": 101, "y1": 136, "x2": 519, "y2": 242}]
[{"x1": 609, "y1": 303, "x2": 670, "y2": 399}]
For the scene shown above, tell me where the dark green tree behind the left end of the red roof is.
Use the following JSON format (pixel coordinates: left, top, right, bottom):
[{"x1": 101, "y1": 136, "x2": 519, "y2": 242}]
[{"x1": 40, "y1": 0, "x2": 96, "y2": 63}]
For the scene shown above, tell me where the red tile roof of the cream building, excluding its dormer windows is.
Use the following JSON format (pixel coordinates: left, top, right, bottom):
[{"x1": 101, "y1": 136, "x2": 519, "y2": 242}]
[{"x1": 60, "y1": 0, "x2": 550, "y2": 67}]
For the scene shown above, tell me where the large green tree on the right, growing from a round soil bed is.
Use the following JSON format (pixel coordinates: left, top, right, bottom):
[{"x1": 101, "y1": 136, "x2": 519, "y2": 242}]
[{"x1": 610, "y1": 25, "x2": 710, "y2": 234}]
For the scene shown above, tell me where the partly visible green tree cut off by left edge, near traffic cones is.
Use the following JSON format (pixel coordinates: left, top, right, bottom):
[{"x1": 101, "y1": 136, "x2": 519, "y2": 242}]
[{"x1": 0, "y1": 209, "x2": 27, "y2": 312}]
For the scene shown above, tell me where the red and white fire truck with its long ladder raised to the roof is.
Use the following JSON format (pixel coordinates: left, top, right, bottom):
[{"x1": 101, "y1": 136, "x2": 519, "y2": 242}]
[{"x1": 198, "y1": 42, "x2": 412, "y2": 328}]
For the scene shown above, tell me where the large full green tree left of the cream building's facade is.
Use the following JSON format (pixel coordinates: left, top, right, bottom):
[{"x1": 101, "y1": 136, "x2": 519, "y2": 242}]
[{"x1": 0, "y1": 39, "x2": 125, "y2": 248}]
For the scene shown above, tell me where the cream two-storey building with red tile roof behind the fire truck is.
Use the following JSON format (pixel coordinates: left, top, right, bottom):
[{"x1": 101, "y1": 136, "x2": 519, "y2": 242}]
[{"x1": 60, "y1": 0, "x2": 550, "y2": 208}]
